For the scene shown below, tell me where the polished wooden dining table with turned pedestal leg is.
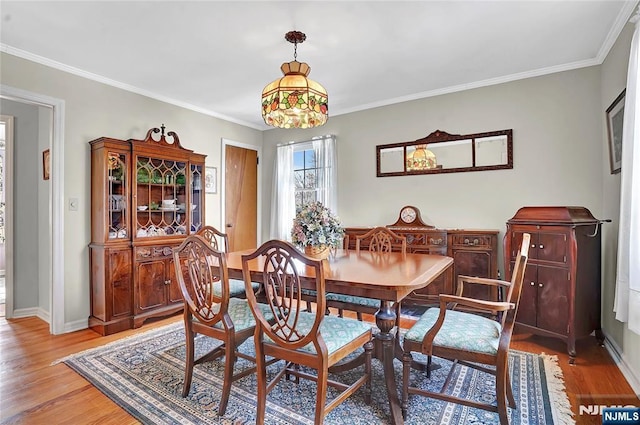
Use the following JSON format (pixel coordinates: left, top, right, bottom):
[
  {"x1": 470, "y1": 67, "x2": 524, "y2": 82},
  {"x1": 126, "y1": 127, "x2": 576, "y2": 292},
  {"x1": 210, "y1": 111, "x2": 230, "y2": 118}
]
[{"x1": 227, "y1": 249, "x2": 453, "y2": 424}]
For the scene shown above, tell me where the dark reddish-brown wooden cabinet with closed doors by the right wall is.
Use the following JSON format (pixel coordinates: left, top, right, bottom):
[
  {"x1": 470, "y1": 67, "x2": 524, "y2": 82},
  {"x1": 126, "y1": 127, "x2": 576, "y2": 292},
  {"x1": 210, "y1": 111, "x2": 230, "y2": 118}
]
[{"x1": 504, "y1": 206, "x2": 603, "y2": 363}]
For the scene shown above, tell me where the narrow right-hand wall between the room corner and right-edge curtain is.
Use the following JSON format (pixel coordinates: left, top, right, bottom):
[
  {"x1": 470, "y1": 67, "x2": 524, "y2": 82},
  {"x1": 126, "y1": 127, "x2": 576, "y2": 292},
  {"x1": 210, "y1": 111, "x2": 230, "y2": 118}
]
[{"x1": 600, "y1": 20, "x2": 640, "y2": 393}]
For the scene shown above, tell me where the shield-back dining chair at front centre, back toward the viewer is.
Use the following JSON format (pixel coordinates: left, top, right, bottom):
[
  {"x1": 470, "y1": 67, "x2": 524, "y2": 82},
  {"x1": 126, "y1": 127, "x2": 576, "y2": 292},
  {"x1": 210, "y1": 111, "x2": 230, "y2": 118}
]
[{"x1": 242, "y1": 240, "x2": 373, "y2": 425}]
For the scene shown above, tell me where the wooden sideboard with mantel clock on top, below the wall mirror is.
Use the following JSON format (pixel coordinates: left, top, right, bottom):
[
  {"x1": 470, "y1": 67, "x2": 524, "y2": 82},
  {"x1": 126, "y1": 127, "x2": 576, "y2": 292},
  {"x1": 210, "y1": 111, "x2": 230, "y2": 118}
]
[{"x1": 345, "y1": 206, "x2": 499, "y2": 305}]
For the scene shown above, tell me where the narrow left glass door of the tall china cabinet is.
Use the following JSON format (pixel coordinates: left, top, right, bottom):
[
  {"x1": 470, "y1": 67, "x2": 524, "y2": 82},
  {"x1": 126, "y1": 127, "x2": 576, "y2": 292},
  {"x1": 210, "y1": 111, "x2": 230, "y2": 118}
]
[{"x1": 107, "y1": 152, "x2": 129, "y2": 240}]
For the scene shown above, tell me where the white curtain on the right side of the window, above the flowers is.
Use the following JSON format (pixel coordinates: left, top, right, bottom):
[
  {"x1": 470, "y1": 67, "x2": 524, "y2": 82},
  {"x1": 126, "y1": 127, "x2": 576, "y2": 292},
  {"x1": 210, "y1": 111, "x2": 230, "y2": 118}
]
[{"x1": 313, "y1": 136, "x2": 338, "y2": 214}]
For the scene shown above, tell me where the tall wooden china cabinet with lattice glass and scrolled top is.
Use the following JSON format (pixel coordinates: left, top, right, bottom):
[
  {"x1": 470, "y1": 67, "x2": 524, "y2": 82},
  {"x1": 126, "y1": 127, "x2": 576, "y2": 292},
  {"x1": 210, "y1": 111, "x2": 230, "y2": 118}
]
[{"x1": 89, "y1": 126, "x2": 205, "y2": 335}]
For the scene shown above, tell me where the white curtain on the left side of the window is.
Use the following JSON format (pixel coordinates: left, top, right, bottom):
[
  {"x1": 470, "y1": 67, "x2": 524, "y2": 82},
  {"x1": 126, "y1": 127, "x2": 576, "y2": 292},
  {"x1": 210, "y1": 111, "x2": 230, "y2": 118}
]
[{"x1": 271, "y1": 144, "x2": 296, "y2": 241}]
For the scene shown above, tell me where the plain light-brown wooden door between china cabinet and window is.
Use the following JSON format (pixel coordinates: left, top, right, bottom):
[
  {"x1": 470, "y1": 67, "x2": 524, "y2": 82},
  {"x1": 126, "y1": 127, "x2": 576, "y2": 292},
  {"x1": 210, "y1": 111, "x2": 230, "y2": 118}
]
[{"x1": 224, "y1": 145, "x2": 258, "y2": 251}]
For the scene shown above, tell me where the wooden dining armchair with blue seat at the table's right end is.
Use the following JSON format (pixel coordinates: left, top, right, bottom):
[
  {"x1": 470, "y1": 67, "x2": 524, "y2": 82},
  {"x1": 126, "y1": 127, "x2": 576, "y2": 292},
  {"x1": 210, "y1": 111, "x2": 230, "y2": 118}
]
[{"x1": 402, "y1": 233, "x2": 531, "y2": 425}]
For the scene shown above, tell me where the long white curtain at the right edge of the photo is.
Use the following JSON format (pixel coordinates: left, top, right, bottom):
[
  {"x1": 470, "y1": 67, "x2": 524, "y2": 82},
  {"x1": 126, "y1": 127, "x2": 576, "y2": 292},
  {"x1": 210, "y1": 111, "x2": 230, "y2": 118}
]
[{"x1": 614, "y1": 12, "x2": 640, "y2": 335}]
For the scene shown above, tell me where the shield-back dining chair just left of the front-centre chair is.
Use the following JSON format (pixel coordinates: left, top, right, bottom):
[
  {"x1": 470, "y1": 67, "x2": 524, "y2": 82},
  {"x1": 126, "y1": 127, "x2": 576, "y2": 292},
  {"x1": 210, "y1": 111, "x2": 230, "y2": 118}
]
[{"x1": 173, "y1": 235, "x2": 273, "y2": 416}]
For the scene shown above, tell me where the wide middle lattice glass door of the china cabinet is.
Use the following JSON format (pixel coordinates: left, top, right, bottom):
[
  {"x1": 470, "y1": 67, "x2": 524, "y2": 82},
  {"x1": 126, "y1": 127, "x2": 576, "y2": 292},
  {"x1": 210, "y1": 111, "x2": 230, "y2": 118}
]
[{"x1": 134, "y1": 156, "x2": 188, "y2": 238}]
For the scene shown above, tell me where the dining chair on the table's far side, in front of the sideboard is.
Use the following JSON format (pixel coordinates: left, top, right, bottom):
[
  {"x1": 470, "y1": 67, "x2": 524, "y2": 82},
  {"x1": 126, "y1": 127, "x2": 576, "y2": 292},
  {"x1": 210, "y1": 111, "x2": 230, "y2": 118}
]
[{"x1": 327, "y1": 227, "x2": 407, "y2": 323}]
